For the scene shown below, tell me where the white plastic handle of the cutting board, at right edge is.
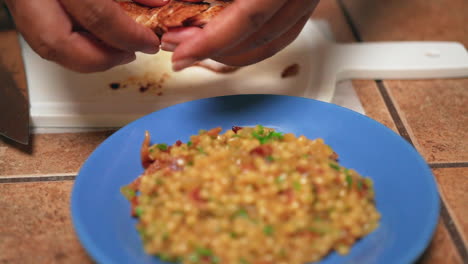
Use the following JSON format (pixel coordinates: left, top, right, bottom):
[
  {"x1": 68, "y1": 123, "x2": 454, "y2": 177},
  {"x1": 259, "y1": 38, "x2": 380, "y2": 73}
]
[{"x1": 333, "y1": 42, "x2": 468, "y2": 80}]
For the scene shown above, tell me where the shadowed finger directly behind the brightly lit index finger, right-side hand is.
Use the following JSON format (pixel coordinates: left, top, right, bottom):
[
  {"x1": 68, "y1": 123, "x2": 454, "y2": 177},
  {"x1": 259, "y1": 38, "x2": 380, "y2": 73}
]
[{"x1": 223, "y1": 0, "x2": 320, "y2": 55}]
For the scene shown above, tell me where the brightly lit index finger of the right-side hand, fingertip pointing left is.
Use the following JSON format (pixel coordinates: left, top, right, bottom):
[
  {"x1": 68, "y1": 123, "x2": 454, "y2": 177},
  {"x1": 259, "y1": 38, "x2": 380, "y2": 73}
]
[{"x1": 172, "y1": 0, "x2": 287, "y2": 70}]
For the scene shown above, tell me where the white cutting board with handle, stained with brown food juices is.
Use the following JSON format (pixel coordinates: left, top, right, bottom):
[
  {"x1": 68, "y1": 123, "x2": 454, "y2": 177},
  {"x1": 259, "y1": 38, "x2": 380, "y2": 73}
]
[{"x1": 21, "y1": 21, "x2": 468, "y2": 127}]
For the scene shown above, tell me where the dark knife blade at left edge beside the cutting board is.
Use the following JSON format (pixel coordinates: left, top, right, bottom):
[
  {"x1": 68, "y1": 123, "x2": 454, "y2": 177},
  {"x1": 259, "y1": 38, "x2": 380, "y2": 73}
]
[{"x1": 0, "y1": 1, "x2": 29, "y2": 145}]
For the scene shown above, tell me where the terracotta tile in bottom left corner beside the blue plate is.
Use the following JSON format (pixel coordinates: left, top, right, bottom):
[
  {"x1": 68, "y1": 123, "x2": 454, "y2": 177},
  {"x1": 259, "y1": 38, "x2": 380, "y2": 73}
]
[{"x1": 0, "y1": 181, "x2": 91, "y2": 263}]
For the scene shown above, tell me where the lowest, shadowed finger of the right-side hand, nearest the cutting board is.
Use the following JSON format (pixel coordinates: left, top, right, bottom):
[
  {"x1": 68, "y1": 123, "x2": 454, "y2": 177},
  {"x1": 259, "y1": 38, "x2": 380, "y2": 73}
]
[{"x1": 213, "y1": 15, "x2": 309, "y2": 67}]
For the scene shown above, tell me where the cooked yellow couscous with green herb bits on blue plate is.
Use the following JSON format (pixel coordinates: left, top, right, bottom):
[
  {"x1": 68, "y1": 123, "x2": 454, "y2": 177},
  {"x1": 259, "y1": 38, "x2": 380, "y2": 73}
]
[{"x1": 122, "y1": 126, "x2": 380, "y2": 264}]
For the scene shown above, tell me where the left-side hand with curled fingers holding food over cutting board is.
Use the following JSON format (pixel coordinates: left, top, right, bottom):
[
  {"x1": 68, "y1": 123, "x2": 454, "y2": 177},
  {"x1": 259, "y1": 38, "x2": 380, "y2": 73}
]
[{"x1": 6, "y1": 0, "x2": 163, "y2": 73}]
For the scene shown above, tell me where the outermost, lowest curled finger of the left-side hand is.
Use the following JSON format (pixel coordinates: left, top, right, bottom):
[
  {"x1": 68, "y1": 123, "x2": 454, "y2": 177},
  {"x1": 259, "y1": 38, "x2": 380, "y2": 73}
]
[{"x1": 8, "y1": 0, "x2": 135, "y2": 72}]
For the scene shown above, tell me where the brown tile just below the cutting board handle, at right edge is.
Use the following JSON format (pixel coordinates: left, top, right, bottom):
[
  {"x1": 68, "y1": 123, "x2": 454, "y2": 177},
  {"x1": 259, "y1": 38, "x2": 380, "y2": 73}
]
[{"x1": 385, "y1": 79, "x2": 468, "y2": 163}]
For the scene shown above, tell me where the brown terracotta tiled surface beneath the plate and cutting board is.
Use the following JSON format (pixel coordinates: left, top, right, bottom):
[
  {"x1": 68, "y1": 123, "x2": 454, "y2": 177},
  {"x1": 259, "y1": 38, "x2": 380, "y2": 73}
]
[{"x1": 0, "y1": 0, "x2": 468, "y2": 264}]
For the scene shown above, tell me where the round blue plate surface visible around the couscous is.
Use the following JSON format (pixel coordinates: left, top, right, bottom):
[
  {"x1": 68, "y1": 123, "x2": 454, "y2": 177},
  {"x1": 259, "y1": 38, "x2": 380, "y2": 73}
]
[{"x1": 71, "y1": 95, "x2": 439, "y2": 264}]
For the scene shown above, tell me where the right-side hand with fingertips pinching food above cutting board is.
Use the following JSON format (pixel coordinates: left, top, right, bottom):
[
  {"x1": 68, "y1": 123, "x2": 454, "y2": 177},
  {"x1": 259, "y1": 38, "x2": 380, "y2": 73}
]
[{"x1": 162, "y1": 0, "x2": 319, "y2": 70}]
